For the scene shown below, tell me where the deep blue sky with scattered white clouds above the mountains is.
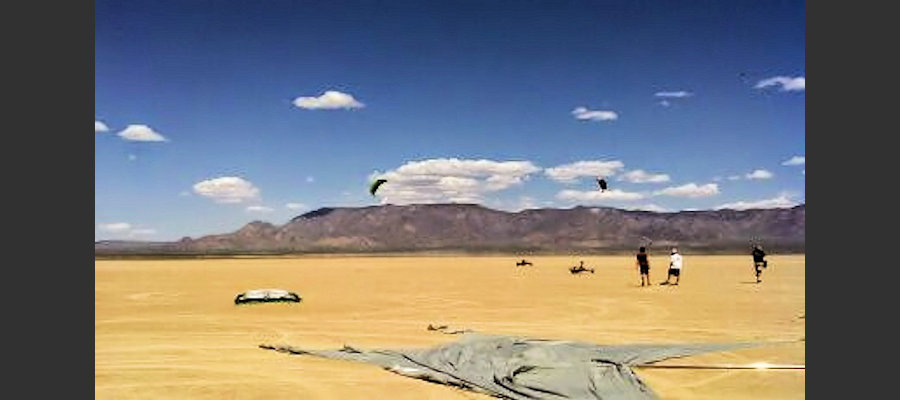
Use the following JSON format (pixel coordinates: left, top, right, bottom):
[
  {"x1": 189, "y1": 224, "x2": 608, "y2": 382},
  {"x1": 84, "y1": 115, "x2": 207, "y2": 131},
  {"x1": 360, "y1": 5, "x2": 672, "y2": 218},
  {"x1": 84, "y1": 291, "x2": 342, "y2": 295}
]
[{"x1": 94, "y1": 1, "x2": 806, "y2": 240}]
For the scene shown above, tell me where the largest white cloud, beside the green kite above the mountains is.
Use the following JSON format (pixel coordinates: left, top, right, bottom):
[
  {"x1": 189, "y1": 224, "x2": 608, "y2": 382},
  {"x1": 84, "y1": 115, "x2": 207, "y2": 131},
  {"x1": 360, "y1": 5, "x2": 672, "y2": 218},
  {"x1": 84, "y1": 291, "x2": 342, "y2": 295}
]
[{"x1": 369, "y1": 158, "x2": 540, "y2": 204}]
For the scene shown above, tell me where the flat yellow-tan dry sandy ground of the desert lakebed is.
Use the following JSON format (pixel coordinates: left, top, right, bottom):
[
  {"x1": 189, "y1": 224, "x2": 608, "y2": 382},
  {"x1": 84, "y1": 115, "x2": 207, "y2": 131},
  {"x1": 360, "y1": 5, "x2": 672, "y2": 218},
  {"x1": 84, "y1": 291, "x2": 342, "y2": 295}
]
[{"x1": 94, "y1": 254, "x2": 806, "y2": 399}]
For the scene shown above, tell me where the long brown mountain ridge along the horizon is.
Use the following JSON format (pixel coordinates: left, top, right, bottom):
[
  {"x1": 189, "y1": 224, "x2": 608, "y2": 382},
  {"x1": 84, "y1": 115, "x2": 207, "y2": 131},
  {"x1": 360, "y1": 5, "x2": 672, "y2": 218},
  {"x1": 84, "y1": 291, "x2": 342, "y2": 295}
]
[{"x1": 94, "y1": 204, "x2": 806, "y2": 255}]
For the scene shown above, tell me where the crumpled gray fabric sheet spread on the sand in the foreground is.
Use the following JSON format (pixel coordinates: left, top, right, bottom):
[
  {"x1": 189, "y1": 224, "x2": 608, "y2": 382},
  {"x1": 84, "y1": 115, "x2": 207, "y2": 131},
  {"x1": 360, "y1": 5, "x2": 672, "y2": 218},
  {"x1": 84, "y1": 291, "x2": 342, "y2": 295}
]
[{"x1": 260, "y1": 333, "x2": 754, "y2": 400}]
